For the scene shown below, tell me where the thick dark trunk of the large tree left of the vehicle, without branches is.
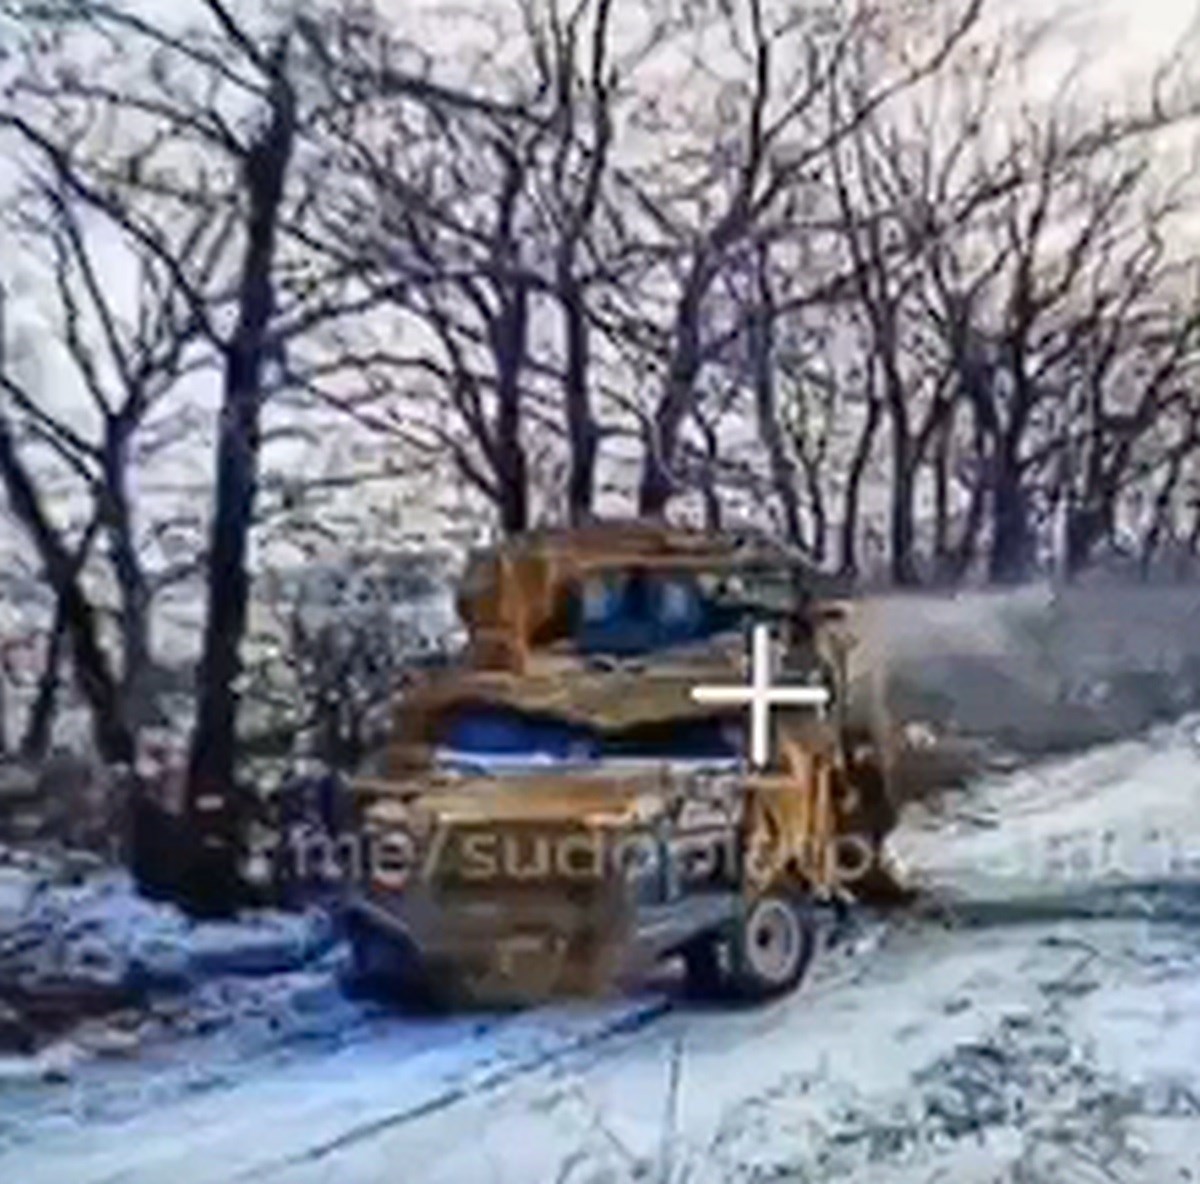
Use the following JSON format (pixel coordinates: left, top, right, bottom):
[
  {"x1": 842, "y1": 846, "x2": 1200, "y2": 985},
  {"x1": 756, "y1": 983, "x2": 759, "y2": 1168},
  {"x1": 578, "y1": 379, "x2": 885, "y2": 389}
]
[{"x1": 181, "y1": 60, "x2": 295, "y2": 915}]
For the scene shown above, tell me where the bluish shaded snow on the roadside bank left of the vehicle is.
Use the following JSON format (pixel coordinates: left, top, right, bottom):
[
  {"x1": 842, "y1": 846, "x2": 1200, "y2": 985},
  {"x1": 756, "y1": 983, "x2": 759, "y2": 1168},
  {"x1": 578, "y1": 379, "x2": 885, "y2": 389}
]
[{"x1": 0, "y1": 849, "x2": 340, "y2": 1103}]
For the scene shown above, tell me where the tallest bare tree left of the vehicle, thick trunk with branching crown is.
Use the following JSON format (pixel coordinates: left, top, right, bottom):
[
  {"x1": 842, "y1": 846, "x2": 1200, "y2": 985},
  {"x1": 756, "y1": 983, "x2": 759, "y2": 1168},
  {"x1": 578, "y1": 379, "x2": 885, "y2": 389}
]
[{"x1": 0, "y1": 0, "x2": 350, "y2": 907}]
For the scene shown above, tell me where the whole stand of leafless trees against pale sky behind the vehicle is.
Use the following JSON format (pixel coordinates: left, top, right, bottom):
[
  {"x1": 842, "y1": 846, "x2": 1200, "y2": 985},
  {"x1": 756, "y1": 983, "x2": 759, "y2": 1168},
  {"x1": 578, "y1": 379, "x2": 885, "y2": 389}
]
[{"x1": 0, "y1": 0, "x2": 1200, "y2": 858}]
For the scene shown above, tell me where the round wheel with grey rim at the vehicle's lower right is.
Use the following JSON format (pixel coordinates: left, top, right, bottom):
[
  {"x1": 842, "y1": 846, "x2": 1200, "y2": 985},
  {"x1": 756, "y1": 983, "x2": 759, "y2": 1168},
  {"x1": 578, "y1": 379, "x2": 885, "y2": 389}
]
[{"x1": 731, "y1": 892, "x2": 815, "y2": 999}]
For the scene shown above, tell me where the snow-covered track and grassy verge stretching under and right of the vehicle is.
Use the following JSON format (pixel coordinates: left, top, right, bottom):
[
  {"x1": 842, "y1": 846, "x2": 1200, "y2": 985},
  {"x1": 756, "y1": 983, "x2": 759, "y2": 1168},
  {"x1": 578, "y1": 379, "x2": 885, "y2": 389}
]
[{"x1": 0, "y1": 720, "x2": 1200, "y2": 1184}]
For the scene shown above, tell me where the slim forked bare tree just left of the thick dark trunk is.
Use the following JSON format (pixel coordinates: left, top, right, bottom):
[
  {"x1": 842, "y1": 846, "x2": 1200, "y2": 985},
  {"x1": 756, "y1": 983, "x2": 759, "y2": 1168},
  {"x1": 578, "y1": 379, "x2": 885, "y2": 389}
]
[{"x1": 0, "y1": 159, "x2": 223, "y2": 732}]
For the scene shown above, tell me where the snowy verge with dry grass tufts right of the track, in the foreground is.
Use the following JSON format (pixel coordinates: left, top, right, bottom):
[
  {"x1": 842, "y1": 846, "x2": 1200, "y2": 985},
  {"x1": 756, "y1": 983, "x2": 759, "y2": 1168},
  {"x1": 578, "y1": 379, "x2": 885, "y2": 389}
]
[{"x1": 307, "y1": 922, "x2": 1200, "y2": 1184}]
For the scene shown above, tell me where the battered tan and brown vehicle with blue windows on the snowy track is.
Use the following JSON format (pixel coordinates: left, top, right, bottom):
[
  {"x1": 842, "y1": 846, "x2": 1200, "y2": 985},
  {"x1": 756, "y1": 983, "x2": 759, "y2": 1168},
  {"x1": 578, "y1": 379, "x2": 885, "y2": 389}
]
[{"x1": 347, "y1": 523, "x2": 898, "y2": 999}]
